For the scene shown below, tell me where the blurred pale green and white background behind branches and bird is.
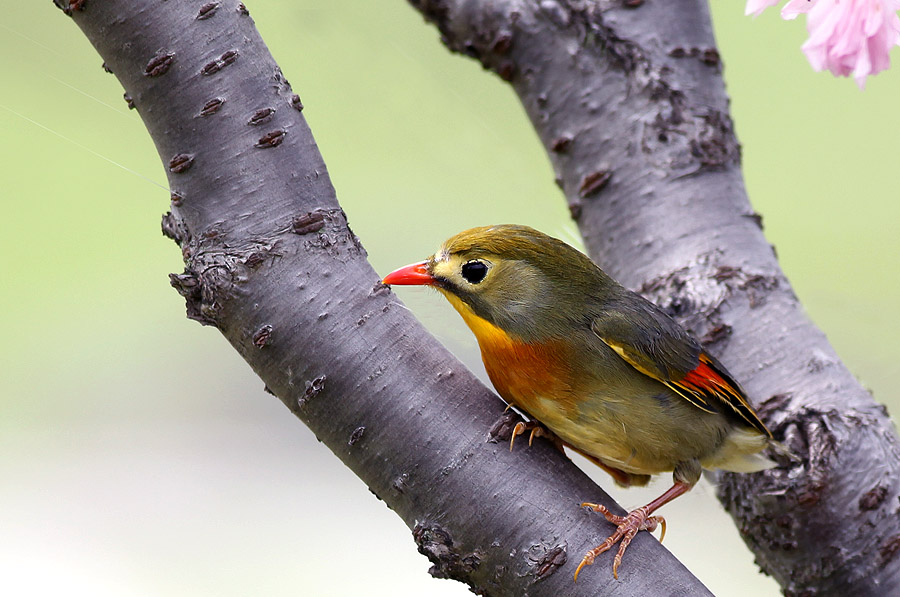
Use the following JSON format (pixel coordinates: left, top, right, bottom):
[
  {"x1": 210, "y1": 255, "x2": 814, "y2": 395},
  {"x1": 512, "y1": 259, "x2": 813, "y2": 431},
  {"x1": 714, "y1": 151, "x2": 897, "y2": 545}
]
[{"x1": 0, "y1": 0, "x2": 900, "y2": 596}]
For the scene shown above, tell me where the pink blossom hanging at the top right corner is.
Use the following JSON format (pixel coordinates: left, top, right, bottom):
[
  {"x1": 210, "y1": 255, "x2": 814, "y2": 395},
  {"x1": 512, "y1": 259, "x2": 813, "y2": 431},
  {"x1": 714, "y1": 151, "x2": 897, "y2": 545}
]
[{"x1": 746, "y1": 0, "x2": 900, "y2": 88}]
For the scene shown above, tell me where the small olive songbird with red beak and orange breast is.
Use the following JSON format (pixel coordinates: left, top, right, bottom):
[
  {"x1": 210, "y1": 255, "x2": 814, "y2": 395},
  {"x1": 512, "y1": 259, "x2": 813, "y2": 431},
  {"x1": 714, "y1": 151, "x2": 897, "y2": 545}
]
[{"x1": 383, "y1": 225, "x2": 778, "y2": 580}]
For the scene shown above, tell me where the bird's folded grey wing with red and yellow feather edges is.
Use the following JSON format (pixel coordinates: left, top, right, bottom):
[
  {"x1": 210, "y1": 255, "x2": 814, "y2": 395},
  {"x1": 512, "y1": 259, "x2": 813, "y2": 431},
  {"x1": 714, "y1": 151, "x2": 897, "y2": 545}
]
[{"x1": 591, "y1": 297, "x2": 772, "y2": 437}]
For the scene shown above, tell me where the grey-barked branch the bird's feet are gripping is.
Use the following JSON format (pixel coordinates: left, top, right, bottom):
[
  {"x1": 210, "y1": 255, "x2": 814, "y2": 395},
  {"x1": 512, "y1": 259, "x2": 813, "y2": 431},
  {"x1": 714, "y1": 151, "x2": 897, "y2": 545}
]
[{"x1": 57, "y1": 0, "x2": 708, "y2": 596}]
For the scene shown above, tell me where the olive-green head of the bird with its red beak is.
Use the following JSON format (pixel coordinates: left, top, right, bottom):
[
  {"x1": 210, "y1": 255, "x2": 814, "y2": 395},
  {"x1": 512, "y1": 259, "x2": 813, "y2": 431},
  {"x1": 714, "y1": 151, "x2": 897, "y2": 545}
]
[{"x1": 383, "y1": 225, "x2": 615, "y2": 342}]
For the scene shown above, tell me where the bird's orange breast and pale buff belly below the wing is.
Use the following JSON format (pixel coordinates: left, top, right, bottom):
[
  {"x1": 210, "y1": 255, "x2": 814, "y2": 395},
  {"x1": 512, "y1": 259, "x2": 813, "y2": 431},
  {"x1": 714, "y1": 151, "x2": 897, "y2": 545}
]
[{"x1": 479, "y1": 322, "x2": 765, "y2": 475}]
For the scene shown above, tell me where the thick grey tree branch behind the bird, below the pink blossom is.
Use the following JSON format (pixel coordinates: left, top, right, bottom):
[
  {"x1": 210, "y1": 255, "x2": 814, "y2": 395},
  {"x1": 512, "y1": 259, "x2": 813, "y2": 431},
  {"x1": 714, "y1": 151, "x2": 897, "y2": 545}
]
[{"x1": 410, "y1": 0, "x2": 900, "y2": 595}]
